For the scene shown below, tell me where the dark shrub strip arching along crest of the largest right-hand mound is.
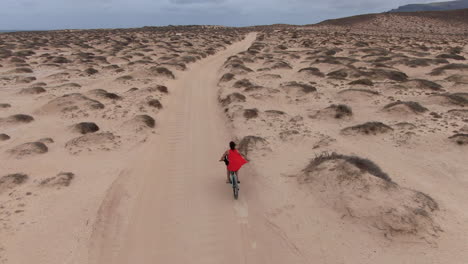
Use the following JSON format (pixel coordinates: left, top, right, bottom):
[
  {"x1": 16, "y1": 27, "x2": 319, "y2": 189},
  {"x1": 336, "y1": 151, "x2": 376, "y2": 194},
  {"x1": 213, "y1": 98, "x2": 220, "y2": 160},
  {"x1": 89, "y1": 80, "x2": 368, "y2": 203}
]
[{"x1": 304, "y1": 152, "x2": 392, "y2": 182}]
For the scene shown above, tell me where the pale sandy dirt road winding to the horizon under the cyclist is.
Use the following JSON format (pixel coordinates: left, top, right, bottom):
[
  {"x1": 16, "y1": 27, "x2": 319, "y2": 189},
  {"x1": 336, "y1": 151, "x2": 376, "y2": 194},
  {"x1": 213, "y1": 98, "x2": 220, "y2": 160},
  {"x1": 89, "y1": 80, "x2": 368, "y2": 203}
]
[{"x1": 90, "y1": 34, "x2": 308, "y2": 264}]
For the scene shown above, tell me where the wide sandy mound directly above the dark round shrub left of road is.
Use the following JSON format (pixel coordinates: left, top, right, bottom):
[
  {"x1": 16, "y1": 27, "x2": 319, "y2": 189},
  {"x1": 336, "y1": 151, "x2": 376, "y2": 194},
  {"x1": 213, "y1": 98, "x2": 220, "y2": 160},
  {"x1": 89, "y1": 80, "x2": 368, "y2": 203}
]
[{"x1": 39, "y1": 93, "x2": 104, "y2": 114}]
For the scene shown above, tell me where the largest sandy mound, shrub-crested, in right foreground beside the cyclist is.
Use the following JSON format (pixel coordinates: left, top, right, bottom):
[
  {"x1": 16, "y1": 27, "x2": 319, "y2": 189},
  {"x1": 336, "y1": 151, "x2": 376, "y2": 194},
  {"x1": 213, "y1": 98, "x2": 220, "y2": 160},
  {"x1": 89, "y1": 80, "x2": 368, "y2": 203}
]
[{"x1": 300, "y1": 153, "x2": 441, "y2": 239}]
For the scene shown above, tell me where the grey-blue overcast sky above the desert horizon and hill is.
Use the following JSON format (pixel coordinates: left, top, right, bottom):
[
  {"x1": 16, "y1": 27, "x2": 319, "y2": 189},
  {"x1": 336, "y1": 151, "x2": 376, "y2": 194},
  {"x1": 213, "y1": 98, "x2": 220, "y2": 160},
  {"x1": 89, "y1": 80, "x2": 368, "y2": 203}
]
[{"x1": 0, "y1": 0, "x2": 448, "y2": 30}]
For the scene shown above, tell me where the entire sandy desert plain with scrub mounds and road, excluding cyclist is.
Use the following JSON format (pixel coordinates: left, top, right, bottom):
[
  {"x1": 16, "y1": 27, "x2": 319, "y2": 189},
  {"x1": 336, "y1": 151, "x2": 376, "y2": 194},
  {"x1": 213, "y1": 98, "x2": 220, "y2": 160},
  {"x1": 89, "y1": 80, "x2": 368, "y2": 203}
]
[{"x1": 0, "y1": 12, "x2": 468, "y2": 264}]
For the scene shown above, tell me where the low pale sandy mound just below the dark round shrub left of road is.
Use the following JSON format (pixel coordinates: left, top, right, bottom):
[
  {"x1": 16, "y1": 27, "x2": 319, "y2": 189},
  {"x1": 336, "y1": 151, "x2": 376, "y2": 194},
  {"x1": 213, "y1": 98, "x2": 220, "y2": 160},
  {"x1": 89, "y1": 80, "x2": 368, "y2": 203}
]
[{"x1": 65, "y1": 132, "x2": 120, "y2": 154}]
